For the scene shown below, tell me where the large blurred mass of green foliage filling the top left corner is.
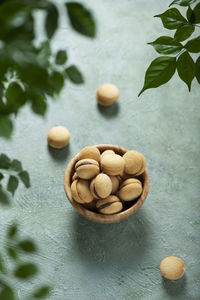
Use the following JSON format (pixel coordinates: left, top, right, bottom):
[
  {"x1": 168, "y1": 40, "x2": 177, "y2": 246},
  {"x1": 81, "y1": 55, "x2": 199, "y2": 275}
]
[{"x1": 0, "y1": 0, "x2": 96, "y2": 138}]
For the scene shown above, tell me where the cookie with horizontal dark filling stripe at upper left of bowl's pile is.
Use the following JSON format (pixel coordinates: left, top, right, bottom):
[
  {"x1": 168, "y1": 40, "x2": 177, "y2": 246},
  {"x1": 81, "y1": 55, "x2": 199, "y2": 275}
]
[{"x1": 75, "y1": 158, "x2": 100, "y2": 179}]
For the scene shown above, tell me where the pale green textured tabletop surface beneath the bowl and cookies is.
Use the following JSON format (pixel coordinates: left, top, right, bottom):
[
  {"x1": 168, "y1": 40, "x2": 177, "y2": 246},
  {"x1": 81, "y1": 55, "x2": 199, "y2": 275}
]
[{"x1": 0, "y1": 0, "x2": 200, "y2": 300}]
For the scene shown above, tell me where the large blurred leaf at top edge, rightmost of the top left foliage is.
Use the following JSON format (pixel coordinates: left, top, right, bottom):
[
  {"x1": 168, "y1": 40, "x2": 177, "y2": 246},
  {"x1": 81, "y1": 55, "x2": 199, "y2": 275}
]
[{"x1": 65, "y1": 2, "x2": 96, "y2": 38}]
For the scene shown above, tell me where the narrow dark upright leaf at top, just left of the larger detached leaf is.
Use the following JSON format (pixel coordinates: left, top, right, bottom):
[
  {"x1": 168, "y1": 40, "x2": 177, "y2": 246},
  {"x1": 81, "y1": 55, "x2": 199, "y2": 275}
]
[{"x1": 45, "y1": 3, "x2": 58, "y2": 39}]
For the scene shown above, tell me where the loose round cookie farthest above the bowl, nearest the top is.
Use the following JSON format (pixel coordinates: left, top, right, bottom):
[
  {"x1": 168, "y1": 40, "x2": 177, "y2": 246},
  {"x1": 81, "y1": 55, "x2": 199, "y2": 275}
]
[{"x1": 96, "y1": 83, "x2": 119, "y2": 106}]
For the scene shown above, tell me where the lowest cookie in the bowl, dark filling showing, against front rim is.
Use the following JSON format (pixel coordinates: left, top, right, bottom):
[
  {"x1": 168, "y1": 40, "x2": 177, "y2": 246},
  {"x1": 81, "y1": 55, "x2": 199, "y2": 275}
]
[{"x1": 96, "y1": 195, "x2": 123, "y2": 215}]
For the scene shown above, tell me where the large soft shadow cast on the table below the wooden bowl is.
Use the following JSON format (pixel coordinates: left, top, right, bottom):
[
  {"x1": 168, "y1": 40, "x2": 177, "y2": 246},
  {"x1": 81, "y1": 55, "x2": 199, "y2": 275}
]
[{"x1": 72, "y1": 211, "x2": 151, "y2": 268}]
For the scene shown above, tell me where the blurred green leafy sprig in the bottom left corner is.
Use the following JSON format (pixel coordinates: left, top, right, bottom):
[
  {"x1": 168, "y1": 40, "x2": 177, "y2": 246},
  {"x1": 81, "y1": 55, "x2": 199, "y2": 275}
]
[{"x1": 0, "y1": 223, "x2": 51, "y2": 300}]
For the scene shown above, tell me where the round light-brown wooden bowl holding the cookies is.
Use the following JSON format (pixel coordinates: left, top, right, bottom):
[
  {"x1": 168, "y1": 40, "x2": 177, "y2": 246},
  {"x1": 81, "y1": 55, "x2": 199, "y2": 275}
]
[{"x1": 64, "y1": 144, "x2": 149, "y2": 223}]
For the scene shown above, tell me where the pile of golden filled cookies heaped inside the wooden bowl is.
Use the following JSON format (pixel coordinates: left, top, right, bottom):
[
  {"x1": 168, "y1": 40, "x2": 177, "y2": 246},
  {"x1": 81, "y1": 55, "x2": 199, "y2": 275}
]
[{"x1": 71, "y1": 146, "x2": 146, "y2": 215}]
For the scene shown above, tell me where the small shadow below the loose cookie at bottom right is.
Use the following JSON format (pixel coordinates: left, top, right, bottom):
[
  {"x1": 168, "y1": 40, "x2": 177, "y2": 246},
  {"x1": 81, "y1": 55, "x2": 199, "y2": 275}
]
[{"x1": 162, "y1": 275, "x2": 189, "y2": 299}]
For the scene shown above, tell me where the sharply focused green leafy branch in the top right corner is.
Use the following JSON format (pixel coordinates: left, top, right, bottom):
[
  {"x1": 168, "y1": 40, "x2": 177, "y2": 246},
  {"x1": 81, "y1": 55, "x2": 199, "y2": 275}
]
[{"x1": 138, "y1": 0, "x2": 200, "y2": 96}]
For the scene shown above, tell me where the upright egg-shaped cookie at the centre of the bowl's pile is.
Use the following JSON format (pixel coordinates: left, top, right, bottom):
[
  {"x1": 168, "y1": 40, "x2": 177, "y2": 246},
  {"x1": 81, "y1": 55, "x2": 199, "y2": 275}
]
[{"x1": 90, "y1": 173, "x2": 112, "y2": 199}]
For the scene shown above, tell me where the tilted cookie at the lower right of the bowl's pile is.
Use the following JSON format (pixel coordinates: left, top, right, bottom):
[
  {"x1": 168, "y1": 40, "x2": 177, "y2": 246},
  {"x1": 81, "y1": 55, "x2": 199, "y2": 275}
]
[{"x1": 118, "y1": 178, "x2": 142, "y2": 201}]
